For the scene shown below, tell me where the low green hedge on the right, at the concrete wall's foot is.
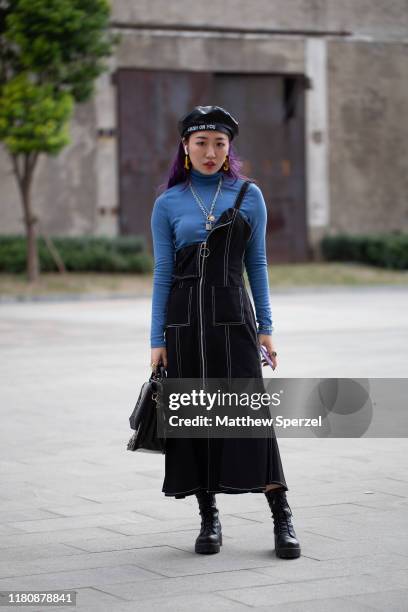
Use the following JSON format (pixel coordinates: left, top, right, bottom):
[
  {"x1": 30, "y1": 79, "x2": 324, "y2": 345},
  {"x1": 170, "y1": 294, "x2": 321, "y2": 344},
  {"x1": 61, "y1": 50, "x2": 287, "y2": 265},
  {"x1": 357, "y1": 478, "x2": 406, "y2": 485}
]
[{"x1": 321, "y1": 233, "x2": 408, "y2": 270}]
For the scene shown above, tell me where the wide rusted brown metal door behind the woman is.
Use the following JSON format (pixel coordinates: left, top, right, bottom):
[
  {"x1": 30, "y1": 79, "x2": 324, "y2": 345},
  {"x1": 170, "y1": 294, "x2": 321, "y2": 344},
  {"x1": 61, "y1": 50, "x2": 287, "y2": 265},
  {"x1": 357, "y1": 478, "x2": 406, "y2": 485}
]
[{"x1": 116, "y1": 69, "x2": 308, "y2": 264}]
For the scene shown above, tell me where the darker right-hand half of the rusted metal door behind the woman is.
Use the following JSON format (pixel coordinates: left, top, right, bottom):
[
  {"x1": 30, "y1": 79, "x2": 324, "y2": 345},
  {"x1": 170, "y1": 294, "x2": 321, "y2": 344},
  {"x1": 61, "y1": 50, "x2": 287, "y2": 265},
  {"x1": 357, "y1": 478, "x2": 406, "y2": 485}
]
[{"x1": 214, "y1": 74, "x2": 308, "y2": 263}]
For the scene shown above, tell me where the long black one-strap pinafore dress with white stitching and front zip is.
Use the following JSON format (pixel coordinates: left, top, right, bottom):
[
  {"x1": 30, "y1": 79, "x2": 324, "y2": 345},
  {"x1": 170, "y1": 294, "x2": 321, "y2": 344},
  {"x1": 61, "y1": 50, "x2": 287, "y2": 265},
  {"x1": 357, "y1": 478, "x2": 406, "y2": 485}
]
[{"x1": 162, "y1": 181, "x2": 288, "y2": 498}]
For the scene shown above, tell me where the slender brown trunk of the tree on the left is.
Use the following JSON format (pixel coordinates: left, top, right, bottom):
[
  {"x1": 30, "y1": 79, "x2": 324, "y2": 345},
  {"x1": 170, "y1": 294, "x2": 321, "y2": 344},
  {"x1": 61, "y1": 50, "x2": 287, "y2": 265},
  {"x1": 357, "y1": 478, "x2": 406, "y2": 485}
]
[{"x1": 13, "y1": 154, "x2": 40, "y2": 283}]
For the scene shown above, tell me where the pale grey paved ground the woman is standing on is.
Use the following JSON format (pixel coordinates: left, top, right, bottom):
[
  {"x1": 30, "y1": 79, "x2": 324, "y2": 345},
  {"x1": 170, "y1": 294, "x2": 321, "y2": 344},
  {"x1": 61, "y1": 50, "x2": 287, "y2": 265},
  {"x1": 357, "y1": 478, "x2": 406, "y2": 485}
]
[{"x1": 0, "y1": 288, "x2": 408, "y2": 612}]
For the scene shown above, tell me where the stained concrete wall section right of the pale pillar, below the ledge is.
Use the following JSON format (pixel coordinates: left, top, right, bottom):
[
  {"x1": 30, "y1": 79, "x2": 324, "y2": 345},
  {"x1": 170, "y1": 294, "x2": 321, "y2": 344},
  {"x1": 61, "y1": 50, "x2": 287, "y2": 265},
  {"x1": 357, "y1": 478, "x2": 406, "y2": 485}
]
[{"x1": 328, "y1": 41, "x2": 408, "y2": 233}]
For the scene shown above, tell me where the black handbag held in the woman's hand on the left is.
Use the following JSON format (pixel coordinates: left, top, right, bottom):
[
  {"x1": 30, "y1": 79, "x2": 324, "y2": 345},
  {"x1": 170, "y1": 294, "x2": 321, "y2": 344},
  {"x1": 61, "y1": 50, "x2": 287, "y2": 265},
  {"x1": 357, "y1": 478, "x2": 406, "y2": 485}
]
[{"x1": 127, "y1": 365, "x2": 167, "y2": 454}]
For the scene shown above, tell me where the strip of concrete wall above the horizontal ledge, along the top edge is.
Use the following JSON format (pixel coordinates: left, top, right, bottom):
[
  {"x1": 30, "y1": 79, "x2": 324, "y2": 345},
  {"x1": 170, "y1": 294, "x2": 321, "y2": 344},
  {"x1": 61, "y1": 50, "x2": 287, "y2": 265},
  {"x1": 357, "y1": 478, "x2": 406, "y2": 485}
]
[{"x1": 113, "y1": 0, "x2": 408, "y2": 38}]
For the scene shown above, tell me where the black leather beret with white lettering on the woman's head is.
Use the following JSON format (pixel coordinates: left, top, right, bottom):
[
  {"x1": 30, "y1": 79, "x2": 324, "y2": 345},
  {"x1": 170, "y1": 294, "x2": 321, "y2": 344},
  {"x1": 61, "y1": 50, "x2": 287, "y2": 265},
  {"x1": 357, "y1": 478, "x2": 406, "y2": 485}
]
[{"x1": 178, "y1": 106, "x2": 238, "y2": 140}]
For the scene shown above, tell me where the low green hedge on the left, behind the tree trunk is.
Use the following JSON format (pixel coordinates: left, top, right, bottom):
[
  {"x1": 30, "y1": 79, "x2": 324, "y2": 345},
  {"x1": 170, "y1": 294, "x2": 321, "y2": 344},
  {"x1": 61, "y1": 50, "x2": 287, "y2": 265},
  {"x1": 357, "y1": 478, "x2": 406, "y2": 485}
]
[{"x1": 0, "y1": 236, "x2": 153, "y2": 274}]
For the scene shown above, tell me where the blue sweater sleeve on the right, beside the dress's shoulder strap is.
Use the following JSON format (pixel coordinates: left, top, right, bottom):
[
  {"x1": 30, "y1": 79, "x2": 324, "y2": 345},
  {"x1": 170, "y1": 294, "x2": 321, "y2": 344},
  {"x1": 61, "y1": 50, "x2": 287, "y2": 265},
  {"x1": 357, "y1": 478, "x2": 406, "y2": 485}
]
[{"x1": 244, "y1": 183, "x2": 274, "y2": 335}]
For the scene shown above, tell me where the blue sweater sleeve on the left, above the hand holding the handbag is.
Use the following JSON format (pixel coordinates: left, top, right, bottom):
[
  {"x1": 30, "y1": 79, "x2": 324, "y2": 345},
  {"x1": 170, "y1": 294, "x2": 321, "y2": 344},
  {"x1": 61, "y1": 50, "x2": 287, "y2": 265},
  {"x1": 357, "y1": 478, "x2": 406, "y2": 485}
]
[{"x1": 150, "y1": 195, "x2": 174, "y2": 348}]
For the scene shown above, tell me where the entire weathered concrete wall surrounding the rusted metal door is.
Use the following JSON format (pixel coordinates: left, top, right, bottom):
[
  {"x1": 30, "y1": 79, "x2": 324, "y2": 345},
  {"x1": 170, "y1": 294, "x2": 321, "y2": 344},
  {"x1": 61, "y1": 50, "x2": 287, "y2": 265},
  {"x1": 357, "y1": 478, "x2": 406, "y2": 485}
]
[{"x1": 0, "y1": 0, "x2": 408, "y2": 250}]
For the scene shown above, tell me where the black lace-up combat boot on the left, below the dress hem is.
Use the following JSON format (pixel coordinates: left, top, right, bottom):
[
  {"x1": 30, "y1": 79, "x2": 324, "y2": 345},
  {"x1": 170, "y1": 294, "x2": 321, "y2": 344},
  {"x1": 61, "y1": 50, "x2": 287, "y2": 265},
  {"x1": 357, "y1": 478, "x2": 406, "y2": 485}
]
[{"x1": 195, "y1": 491, "x2": 222, "y2": 555}]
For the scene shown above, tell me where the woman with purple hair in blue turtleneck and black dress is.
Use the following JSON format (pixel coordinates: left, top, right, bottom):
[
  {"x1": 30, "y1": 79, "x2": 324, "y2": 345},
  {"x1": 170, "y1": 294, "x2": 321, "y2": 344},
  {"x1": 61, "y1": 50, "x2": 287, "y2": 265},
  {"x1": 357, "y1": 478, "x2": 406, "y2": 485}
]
[{"x1": 151, "y1": 106, "x2": 300, "y2": 558}]
